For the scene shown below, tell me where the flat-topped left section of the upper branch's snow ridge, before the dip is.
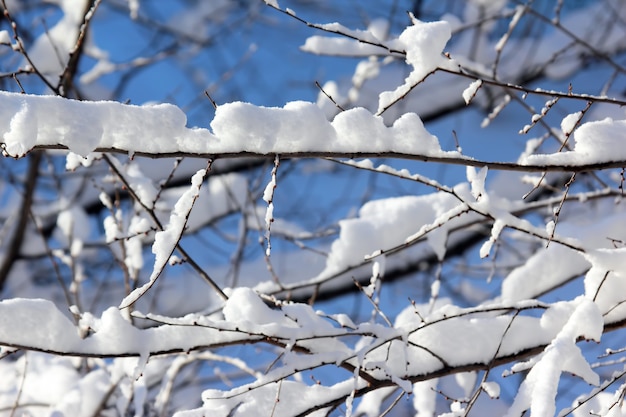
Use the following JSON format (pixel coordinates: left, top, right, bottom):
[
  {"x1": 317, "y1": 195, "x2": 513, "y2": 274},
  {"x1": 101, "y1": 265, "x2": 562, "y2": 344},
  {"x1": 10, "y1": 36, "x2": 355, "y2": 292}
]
[{"x1": 0, "y1": 92, "x2": 194, "y2": 157}]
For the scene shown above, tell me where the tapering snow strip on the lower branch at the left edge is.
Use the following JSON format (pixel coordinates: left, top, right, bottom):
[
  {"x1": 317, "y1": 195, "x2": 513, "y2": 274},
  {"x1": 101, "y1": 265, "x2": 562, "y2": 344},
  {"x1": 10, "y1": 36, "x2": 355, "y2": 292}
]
[{"x1": 0, "y1": 298, "x2": 304, "y2": 357}]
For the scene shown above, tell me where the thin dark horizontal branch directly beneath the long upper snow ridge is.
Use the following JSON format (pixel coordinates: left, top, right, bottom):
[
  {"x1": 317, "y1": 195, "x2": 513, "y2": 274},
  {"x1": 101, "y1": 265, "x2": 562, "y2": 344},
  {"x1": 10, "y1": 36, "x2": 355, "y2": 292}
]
[{"x1": 20, "y1": 145, "x2": 626, "y2": 172}]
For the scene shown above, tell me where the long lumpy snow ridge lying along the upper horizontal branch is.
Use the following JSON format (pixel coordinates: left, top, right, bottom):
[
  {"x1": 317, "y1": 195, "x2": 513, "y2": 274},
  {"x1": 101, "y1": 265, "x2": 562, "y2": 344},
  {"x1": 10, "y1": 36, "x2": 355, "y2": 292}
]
[{"x1": 0, "y1": 92, "x2": 449, "y2": 157}]
